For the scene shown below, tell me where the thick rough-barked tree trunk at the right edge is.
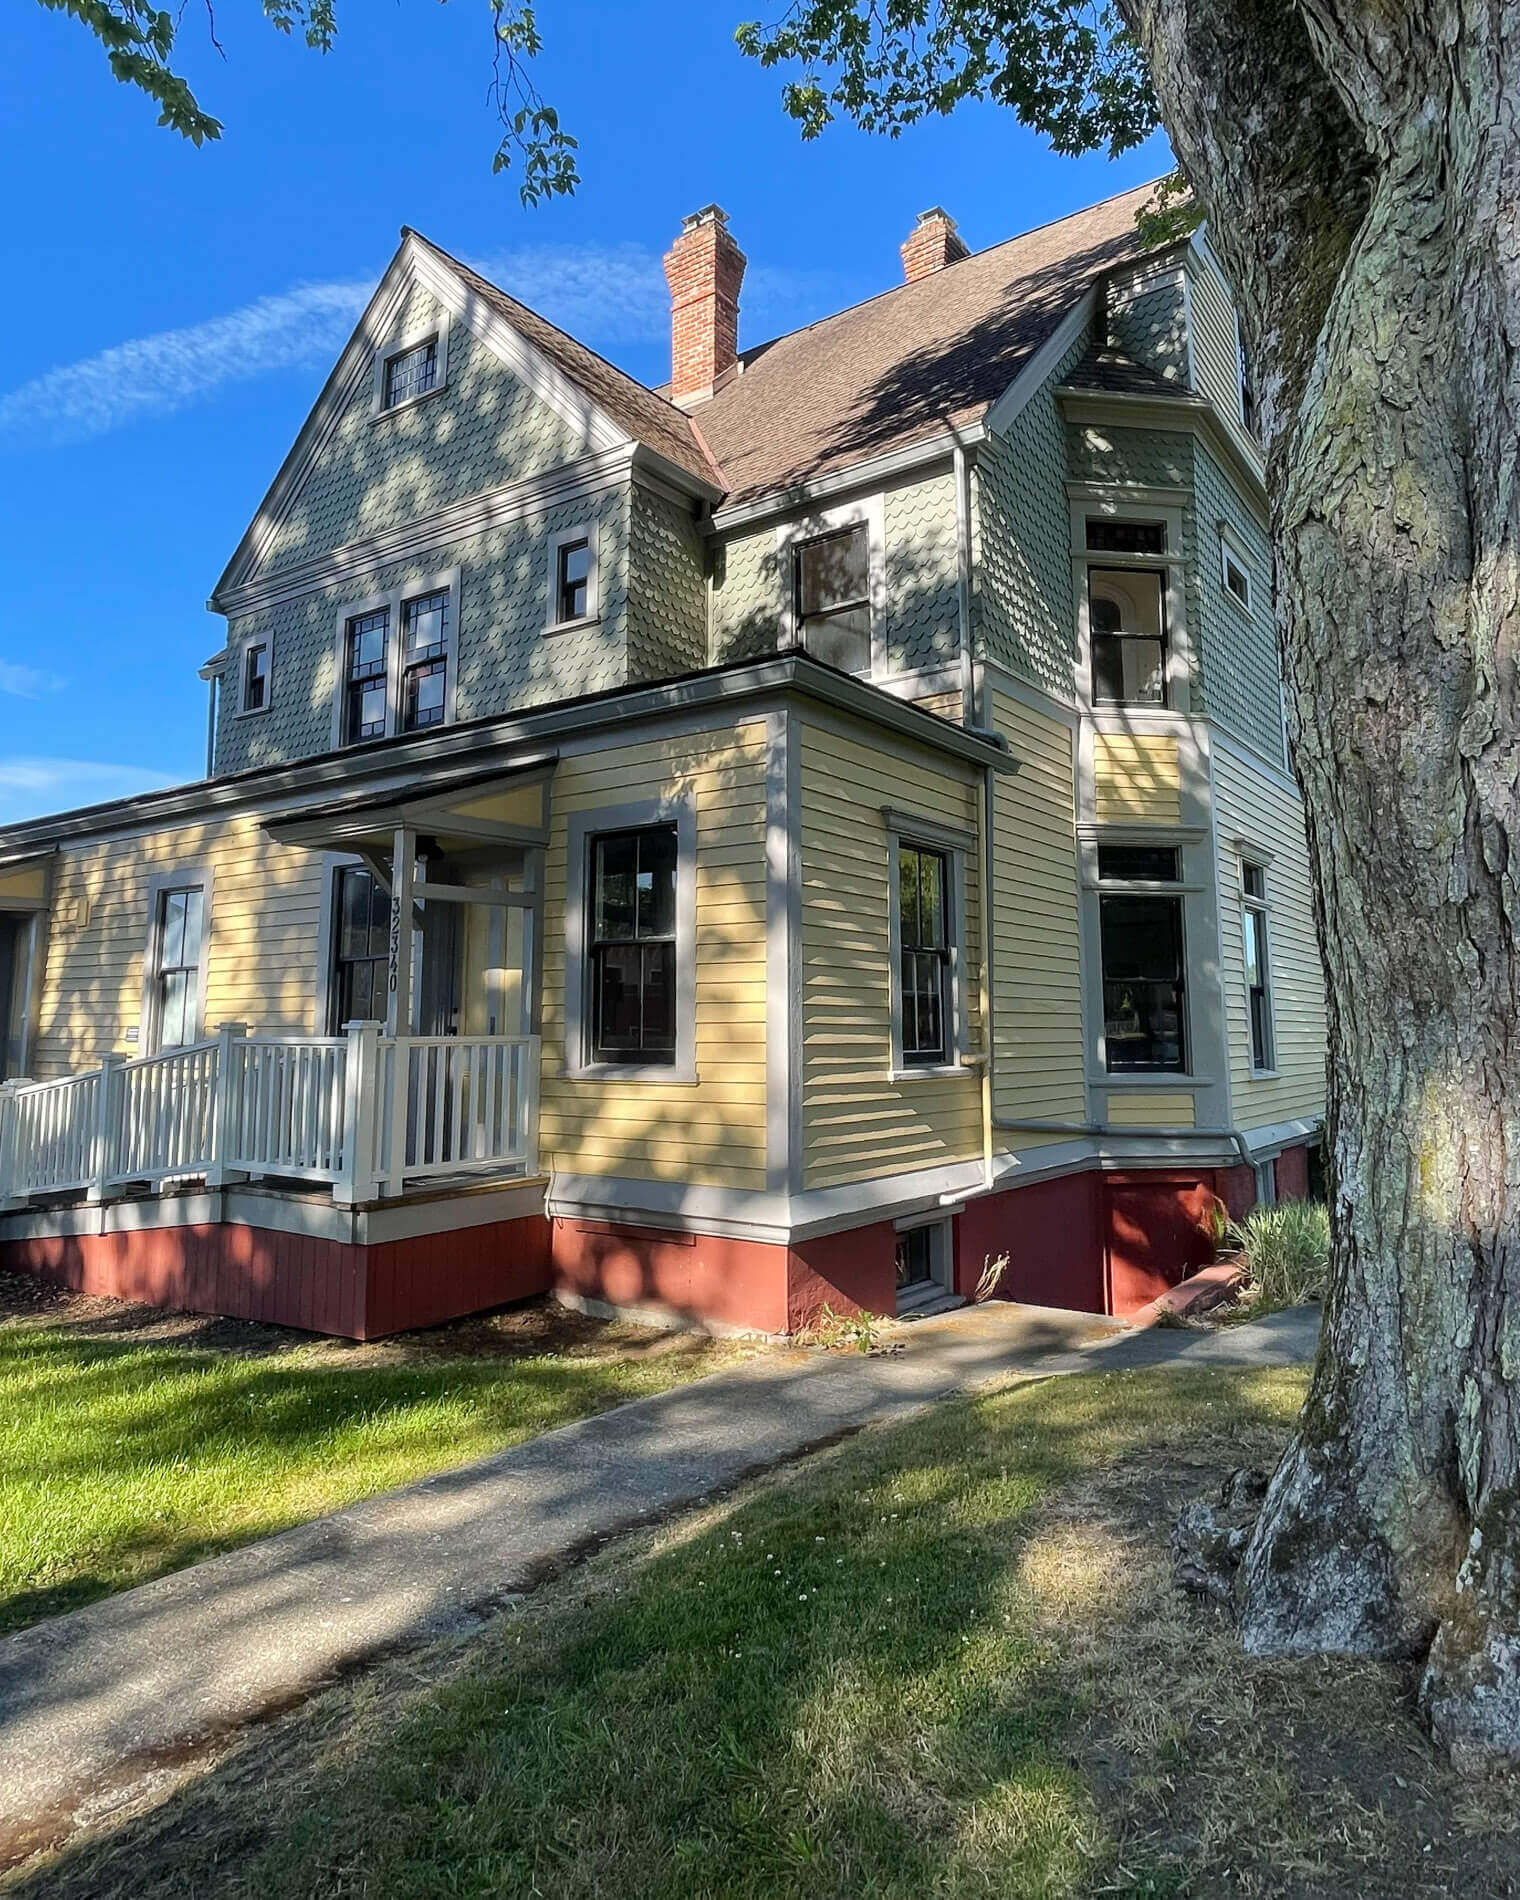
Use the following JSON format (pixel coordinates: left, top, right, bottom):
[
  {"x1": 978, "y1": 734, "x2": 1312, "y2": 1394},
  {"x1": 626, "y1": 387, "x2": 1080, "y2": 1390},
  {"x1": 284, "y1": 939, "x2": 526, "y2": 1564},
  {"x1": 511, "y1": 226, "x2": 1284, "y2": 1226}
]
[{"x1": 1125, "y1": 0, "x2": 1520, "y2": 1761}]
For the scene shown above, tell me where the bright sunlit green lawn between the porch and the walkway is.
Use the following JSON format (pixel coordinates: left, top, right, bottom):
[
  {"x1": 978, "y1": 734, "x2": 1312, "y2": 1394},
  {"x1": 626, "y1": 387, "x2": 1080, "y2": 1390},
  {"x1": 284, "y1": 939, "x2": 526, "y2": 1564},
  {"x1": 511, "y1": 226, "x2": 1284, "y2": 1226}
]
[{"x1": 0, "y1": 1309, "x2": 752, "y2": 1632}]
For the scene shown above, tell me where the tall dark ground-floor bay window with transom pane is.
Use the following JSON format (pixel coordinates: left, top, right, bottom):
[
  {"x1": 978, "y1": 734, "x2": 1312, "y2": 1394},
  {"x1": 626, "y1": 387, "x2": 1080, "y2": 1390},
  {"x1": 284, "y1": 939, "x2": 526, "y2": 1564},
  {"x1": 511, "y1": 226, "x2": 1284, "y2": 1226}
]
[{"x1": 1098, "y1": 846, "x2": 1188, "y2": 1074}]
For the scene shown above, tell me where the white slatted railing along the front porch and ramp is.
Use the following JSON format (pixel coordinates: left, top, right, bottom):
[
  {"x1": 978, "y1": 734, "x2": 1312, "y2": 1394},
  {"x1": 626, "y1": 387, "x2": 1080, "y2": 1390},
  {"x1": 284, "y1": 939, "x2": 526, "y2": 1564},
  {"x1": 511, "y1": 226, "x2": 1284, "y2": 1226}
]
[{"x1": 0, "y1": 1022, "x2": 540, "y2": 1207}]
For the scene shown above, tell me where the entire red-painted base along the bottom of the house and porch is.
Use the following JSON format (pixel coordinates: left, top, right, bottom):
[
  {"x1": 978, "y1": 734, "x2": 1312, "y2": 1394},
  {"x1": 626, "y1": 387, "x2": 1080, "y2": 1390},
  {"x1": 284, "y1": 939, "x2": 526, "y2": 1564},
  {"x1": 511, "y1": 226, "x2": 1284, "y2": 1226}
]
[{"x1": 0, "y1": 1148, "x2": 1307, "y2": 1340}]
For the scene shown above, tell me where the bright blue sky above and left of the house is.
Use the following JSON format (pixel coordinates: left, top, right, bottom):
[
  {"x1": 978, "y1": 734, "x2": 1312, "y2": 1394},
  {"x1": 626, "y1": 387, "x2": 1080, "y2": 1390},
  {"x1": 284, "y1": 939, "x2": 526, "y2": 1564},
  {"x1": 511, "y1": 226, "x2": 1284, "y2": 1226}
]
[{"x1": 0, "y1": 0, "x2": 1169, "y2": 823}]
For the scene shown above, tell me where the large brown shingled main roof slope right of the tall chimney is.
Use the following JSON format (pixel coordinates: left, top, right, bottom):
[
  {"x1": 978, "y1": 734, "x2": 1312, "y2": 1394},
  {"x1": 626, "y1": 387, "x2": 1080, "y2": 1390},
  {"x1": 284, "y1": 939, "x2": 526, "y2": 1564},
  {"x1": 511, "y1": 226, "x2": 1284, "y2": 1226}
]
[{"x1": 692, "y1": 184, "x2": 1153, "y2": 504}]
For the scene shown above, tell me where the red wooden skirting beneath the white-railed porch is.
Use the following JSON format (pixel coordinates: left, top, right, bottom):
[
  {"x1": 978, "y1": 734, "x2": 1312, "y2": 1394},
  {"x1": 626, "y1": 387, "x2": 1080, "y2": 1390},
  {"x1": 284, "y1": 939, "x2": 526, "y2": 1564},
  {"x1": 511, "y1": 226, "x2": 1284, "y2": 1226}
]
[{"x1": 0, "y1": 1216, "x2": 549, "y2": 1340}]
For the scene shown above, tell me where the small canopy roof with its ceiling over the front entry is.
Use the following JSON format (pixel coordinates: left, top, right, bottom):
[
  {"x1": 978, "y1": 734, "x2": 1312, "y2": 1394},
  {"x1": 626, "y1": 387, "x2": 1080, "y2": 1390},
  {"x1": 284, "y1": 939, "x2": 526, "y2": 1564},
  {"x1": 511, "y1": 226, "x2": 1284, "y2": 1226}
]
[{"x1": 264, "y1": 752, "x2": 559, "y2": 853}]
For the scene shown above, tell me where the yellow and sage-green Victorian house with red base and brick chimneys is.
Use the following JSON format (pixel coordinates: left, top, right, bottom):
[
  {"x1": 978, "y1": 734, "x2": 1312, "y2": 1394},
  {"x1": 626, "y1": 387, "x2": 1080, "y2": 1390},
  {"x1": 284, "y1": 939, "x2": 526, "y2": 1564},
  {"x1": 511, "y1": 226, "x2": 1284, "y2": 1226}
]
[{"x1": 0, "y1": 178, "x2": 1324, "y2": 1336}]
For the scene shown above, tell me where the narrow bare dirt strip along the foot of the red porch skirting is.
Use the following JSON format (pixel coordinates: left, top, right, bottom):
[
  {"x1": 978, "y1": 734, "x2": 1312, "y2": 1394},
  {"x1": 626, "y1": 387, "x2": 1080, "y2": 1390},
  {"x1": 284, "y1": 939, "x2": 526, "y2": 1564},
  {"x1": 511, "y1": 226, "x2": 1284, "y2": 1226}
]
[{"x1": 0, "y1": 1273, "x2": 741, "y2": 1368}]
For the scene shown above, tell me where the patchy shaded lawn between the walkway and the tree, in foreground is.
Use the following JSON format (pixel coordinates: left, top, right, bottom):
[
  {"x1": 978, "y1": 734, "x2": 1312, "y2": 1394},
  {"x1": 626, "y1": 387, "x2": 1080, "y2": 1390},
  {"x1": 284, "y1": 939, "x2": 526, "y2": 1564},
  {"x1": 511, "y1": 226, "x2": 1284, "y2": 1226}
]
[{"x1": 14, "y1": 1372, "x2": 1520, "y2": 1900}]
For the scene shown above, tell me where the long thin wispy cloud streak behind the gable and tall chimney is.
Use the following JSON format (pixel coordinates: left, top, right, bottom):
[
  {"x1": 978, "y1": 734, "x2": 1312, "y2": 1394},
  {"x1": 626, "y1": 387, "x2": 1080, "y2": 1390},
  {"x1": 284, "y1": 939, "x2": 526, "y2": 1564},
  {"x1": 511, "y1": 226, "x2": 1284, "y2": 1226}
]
[{"x1": 0, "y1": 243, "x2": 840, "y2": 450}]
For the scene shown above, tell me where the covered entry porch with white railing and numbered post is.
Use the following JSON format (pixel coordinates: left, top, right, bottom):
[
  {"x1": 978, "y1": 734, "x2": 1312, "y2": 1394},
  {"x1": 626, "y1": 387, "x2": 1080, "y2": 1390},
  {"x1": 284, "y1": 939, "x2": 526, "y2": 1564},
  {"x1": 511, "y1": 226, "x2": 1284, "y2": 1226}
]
[{"x1": 0, "y1": 754, "x2": 555, "y2": 1210}]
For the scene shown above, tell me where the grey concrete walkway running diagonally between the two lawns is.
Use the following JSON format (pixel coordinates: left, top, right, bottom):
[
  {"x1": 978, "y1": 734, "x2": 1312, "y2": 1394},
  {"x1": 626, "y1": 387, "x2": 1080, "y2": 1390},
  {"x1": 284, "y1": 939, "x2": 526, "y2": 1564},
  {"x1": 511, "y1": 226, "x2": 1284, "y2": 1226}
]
[{"x1": 0, "y1": 1303, "x2": 1319, "y2": 1868}]
